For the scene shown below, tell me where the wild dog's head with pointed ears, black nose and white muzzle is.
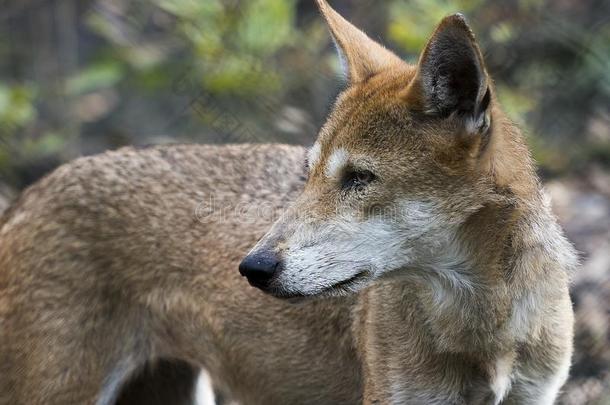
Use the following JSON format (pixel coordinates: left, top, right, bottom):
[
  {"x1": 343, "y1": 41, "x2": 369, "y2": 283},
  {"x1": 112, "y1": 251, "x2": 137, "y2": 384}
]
[{"x1": 240, "y1": 0, "x2": 527, "y2": 297}]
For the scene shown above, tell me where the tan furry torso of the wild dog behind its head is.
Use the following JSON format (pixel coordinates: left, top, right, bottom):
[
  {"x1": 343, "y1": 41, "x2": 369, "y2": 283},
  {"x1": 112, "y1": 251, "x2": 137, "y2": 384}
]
[{"x1": 0, "y1": 145, "x2": 360, "y2": 405}]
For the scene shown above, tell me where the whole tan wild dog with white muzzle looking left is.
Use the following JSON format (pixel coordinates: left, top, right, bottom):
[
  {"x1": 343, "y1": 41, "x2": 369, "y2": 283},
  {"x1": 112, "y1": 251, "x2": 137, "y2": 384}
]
[{"x1": 0, "y1": 0, "x2": 577, "y2": 405}]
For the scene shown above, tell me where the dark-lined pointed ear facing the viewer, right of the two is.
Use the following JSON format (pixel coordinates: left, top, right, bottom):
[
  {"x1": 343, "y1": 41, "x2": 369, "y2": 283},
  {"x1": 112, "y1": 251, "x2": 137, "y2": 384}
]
[{"x1": 407, "y1": 14, "x2": 491, "y2": 132}]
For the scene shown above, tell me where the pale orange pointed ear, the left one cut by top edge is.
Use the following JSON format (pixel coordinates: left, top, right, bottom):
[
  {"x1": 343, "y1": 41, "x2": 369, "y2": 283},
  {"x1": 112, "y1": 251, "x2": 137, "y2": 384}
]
[{"x1": 316, "y1": 0, "x2": 404, "y2": 84}]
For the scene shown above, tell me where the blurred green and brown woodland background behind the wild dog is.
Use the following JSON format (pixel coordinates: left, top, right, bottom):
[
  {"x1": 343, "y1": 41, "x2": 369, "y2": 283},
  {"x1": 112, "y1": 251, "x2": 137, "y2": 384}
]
[{"x1": 0, "y1": 0, "x2": 610, "y2": 404}]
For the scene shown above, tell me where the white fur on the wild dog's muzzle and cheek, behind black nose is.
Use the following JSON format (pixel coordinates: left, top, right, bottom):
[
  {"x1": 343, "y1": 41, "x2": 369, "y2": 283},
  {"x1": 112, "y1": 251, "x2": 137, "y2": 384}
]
[{"x1": 276, "y1": 201, "x2": 439, "y2": 295}]
